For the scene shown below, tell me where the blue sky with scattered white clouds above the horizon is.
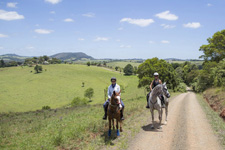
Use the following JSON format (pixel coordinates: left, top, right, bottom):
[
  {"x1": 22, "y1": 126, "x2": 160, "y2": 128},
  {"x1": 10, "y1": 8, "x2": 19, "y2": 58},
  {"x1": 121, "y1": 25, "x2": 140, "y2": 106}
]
[{"x1": 0, "y1": 0, "x2": 225, "y2": 59}]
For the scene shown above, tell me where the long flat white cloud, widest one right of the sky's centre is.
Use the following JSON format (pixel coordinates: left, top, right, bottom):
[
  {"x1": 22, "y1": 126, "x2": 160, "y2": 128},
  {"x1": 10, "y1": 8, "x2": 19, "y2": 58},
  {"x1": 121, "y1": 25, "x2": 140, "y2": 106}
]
[{"x1": 120, "y1": 18, "x2": 154, "y2": 27}]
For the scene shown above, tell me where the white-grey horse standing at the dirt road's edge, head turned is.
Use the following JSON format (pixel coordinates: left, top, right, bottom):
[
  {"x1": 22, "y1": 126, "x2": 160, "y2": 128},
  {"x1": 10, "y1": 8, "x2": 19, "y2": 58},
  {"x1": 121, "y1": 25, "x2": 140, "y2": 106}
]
[{"x1": 148, "y1": 83, "x2": 170, "y2": 129}]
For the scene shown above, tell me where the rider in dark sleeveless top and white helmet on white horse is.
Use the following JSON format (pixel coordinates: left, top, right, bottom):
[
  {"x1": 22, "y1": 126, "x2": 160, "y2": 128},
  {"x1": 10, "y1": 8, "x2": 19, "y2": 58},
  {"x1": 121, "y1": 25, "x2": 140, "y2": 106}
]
[{"x1": 146, "y1": 72, "x2": 165, "y2": 108}]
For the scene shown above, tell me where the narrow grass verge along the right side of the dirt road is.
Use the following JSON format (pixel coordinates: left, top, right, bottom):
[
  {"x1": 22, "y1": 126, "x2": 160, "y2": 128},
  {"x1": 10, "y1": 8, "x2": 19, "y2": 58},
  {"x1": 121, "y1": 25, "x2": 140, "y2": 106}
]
[{"x1": 196, "y1": 94, "x2": 225, "y2": 149}]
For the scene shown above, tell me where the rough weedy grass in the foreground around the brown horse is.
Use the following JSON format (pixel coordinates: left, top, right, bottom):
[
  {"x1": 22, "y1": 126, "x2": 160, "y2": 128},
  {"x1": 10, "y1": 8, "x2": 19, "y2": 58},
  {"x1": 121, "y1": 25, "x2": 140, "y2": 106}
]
[{"x1": 0, "y1": 93, "x2": 180, "y2": 150}]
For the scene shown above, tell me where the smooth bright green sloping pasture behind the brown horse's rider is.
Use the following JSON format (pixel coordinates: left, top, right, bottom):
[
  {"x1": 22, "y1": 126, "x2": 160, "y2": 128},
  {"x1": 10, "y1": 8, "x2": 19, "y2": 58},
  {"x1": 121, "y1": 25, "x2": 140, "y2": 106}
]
[{"x1": 0, "y1": 64, "x2": 144, "y2": 112}]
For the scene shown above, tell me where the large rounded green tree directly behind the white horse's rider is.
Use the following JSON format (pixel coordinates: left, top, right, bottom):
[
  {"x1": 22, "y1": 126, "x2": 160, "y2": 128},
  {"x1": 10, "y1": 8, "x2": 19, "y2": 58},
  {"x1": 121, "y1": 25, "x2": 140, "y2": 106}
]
[{"x1": 137, "y1": 58, "x2": 179, "y2": 90}]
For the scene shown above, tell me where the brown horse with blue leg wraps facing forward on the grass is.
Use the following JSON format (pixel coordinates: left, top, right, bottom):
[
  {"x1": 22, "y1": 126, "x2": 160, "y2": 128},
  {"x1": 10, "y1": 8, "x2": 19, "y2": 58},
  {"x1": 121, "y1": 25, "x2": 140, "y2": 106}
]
[{"x1": 107, "y1": 91, "x2": 123, "y2": 136}]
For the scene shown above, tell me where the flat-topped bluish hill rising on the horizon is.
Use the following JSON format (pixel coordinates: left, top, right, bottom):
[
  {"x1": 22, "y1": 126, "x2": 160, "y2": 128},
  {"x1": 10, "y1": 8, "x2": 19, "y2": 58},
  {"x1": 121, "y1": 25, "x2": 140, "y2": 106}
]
[{"x1": 50, "y1": 52, "x2": 94, "y2": 61}]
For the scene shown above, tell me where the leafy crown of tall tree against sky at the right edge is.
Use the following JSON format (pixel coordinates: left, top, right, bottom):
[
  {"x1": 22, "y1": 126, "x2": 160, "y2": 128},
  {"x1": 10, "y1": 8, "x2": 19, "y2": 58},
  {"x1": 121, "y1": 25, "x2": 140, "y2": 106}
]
[{"x1": 199, "y1": 30, "x2": 225, "y2": 63}]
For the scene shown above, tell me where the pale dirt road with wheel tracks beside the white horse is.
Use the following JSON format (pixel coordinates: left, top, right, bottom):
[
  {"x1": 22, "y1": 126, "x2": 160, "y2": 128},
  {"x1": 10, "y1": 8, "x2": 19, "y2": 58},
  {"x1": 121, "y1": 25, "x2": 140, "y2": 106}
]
[{"x1": 128, "y1": 92, "x2": 222, "y2": 150}]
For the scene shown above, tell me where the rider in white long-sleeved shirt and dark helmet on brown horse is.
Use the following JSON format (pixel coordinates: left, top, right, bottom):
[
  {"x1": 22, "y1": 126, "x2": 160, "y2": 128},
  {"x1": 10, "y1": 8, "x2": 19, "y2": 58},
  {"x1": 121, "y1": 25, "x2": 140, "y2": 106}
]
[{"x1": 103, "y1": 77, "x2": 124, "y2": 120}]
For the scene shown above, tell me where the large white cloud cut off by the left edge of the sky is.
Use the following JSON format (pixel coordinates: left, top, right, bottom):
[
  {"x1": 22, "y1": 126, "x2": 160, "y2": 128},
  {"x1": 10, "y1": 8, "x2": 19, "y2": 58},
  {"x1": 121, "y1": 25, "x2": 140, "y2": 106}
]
[{"x1": 0, "y1": 9, "x2": 24, "y2": 21}]
